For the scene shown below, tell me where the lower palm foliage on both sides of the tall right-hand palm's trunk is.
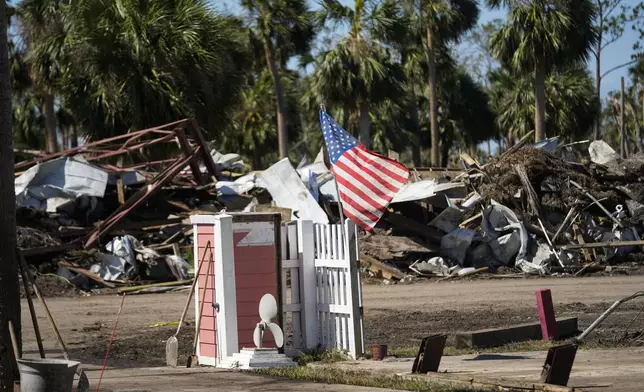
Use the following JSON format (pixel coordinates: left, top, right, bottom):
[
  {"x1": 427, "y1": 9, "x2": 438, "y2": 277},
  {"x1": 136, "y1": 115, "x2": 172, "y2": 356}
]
[{"x1": 490, "y1": 65, "x2": 600, "y2": 145}]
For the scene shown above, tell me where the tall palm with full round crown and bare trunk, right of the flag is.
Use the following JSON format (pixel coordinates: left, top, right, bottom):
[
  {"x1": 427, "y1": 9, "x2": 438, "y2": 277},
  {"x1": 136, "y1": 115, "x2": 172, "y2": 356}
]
[{"x1": 487, "y1": 0, "x2": 597, "y2": 141}]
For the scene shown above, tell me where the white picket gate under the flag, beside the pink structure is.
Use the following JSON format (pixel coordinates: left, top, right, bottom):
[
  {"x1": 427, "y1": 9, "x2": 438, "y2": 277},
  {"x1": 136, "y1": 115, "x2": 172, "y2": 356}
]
[{"x1": 281, "y1": 221, "x2": 364, "y2": 358}]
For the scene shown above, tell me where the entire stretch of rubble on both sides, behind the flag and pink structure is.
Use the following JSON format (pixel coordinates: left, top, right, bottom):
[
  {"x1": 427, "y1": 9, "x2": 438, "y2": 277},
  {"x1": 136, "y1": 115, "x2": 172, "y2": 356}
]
[{"x1": 15, "y1": 120, "x2": 644, "y2": 292}]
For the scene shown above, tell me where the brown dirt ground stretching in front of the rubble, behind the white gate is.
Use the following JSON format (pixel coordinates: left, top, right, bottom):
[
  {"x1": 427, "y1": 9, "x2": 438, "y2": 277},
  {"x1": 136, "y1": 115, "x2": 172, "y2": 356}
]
[{"x1": 22, "y1": 276, "x2": 644, "y2": 367}]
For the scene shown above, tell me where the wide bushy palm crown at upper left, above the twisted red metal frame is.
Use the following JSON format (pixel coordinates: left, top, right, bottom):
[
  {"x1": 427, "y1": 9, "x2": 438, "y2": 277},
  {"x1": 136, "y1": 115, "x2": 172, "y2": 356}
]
[{"x1": 61, "y1": 0, "x2": 249, "y2": 138}]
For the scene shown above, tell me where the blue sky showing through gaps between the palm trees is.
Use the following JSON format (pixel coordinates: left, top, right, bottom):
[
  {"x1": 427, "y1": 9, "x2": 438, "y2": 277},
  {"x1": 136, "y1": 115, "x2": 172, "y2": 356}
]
[{"x1": 219, "y1": 0, "x2": 639, "y2": 96}]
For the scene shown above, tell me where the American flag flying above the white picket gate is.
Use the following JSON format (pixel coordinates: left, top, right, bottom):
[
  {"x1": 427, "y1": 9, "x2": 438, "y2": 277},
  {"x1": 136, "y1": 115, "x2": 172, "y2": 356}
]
[{"x1": 320, "y1": 110, "x2": 409, "y2": 230}]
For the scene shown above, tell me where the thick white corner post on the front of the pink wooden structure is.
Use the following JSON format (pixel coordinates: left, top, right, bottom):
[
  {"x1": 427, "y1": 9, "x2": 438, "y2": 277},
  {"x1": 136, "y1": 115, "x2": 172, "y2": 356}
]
[{"x1": 214, "y1": 214, "x2": 239, "y2": 361}]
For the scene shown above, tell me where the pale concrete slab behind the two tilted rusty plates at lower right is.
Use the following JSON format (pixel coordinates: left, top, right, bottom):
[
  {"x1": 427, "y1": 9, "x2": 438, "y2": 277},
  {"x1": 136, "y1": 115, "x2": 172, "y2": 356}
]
[{"x1": 316, "y1": 348, "x2": 644, "y2": 392}]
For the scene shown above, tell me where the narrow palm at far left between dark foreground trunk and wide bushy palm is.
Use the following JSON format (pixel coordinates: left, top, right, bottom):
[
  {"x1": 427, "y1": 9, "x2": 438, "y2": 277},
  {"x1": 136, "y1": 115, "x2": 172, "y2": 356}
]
[{"x1": 17, "y1": 0, "x2": 65, "y2": 152}]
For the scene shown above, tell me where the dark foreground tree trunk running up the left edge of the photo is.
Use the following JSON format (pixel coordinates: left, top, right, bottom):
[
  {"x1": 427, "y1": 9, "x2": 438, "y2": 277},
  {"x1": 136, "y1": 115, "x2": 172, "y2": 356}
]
[{"x1": 0, "y1": 1, "x2": 21, "y2": 391}]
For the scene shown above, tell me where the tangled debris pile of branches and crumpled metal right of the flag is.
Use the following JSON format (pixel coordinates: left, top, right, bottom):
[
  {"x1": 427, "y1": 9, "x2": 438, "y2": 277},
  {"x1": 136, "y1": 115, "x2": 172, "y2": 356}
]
[{"x1": 370, "y1": 141, "x2": 644, "y2": 279}]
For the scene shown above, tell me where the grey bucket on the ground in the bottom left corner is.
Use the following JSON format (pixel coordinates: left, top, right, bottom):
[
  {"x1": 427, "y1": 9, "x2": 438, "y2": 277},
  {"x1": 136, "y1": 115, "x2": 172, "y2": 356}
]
[{"x1": 18, "y1": 359, "x2": 80, "y2": 392}]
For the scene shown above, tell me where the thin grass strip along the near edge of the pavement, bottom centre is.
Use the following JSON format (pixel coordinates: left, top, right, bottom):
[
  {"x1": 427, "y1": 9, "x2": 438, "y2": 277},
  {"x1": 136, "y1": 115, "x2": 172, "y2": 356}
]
[{"x1": 251, "y1": 366, "x2": 483, "y2": 392}]
